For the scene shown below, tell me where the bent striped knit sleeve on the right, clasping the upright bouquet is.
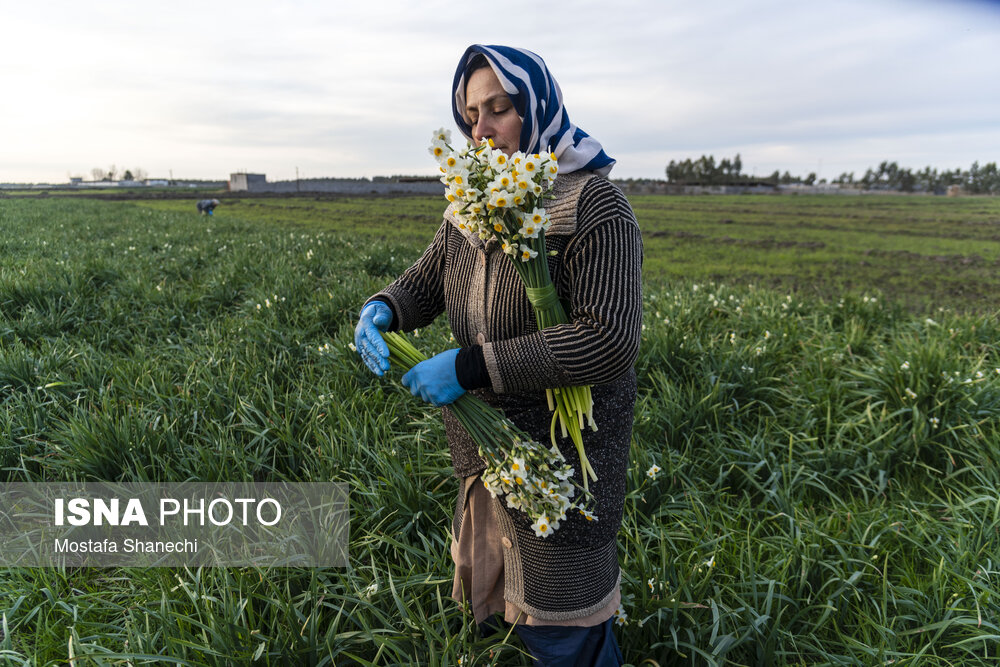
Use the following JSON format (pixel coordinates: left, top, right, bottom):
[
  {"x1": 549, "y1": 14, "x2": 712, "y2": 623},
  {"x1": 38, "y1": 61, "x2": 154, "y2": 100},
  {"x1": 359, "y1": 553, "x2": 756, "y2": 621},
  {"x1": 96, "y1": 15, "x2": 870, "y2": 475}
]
[{"x1": 483, "y1": 178, "x2": 642, "y2": 393}]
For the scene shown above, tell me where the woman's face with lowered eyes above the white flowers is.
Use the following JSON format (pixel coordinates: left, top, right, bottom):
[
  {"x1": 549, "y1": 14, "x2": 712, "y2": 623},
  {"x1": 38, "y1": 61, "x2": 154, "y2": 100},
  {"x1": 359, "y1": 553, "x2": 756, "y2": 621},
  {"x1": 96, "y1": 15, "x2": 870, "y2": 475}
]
[{"x1": 465, "y1": 67, "x2": 521, "y2": 155}]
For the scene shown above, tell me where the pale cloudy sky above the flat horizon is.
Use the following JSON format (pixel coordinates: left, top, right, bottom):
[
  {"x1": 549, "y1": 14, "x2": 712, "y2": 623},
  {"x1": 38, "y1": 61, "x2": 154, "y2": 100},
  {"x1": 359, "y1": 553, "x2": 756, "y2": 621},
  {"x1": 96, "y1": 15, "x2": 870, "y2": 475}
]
[{"x1": 0, "y1": 0, "x2": 1000, "y2": 183}]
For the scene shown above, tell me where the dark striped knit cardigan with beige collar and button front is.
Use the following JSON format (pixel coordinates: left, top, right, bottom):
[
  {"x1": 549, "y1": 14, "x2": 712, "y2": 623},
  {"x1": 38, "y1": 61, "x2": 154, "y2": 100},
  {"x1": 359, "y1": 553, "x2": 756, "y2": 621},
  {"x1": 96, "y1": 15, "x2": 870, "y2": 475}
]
[{"x1": 372, "y1": 172, "x2": 642, "y2": 620}]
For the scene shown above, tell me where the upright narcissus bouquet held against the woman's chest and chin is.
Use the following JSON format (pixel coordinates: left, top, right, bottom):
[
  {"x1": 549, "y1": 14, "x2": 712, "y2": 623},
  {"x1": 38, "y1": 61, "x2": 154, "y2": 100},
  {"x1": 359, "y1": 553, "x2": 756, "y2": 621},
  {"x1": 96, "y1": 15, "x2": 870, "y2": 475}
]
[{"x1": 430, "y1": 129, "x2": 597, "y2": 489}]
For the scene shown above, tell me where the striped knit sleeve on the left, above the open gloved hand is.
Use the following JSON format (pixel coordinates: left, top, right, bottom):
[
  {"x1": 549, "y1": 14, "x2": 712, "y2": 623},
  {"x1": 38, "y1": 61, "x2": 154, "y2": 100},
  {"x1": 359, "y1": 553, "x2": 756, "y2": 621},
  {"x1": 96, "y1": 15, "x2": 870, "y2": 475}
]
[{"x1": 366, "y1": 220, "x2": 449, "y2": 331}]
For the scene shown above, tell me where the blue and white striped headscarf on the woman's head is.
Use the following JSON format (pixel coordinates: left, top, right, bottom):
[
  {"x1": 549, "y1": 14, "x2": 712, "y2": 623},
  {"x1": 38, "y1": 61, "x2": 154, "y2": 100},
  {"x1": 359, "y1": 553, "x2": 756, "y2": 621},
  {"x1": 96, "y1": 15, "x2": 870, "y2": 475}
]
[{"x1": 452, "y1": 44, "x2": 615, "y2": 176}]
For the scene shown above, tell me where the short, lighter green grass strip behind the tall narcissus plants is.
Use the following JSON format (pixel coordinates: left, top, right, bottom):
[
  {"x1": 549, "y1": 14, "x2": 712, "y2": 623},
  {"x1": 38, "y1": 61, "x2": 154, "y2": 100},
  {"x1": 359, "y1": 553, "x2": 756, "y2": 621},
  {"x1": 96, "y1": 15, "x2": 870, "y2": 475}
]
[{"x1": 139, "y1": 190, "x2": 1000, "y2": 311}]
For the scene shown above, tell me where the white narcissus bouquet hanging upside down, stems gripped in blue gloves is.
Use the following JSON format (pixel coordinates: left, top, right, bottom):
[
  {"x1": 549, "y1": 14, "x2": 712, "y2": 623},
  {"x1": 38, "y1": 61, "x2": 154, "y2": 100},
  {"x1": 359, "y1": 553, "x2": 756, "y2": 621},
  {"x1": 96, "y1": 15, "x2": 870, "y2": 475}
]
[{"x1": 382, "y1": 332, "x2": 584, "y2": 537}]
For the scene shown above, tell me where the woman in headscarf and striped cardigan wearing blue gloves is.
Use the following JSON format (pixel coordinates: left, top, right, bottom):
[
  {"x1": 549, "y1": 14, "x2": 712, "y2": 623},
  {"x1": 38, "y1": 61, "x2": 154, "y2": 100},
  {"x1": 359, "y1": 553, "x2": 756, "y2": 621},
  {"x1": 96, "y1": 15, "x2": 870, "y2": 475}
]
[{"x1": 355, "y1": 45, "x2": 642, "y2": 665}]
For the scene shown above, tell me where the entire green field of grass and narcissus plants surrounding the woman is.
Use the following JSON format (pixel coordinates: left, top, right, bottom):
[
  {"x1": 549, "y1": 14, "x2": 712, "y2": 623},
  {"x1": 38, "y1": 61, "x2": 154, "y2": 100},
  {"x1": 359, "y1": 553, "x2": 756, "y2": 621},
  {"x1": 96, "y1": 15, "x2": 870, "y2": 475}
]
[{"x1": 0, "y1": 192, "x2": 1000, "y2": 666}]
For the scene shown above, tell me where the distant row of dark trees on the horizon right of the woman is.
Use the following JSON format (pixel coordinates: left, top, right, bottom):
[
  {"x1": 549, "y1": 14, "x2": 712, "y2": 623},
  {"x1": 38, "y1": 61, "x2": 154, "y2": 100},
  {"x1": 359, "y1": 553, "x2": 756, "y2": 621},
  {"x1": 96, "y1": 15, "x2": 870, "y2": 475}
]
[{"x1": 666, "y1": 153, "x2": 1000, "y2": 195}]
